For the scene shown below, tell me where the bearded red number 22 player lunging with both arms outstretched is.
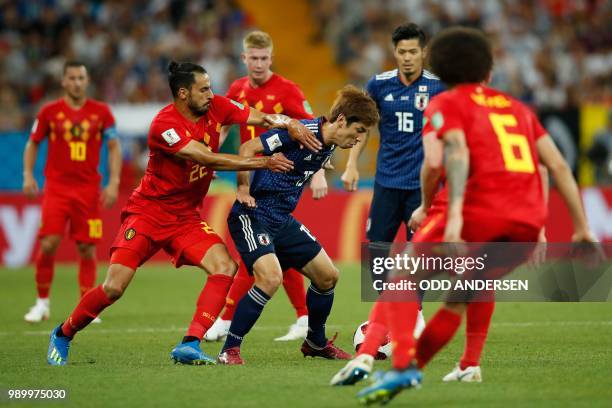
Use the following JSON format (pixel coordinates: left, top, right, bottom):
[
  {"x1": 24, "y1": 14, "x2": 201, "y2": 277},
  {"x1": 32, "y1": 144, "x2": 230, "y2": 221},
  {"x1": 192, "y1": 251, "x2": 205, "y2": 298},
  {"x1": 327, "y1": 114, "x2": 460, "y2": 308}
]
[{"x1": 47, "y1": 62, "x2": 321, "y2": 365}]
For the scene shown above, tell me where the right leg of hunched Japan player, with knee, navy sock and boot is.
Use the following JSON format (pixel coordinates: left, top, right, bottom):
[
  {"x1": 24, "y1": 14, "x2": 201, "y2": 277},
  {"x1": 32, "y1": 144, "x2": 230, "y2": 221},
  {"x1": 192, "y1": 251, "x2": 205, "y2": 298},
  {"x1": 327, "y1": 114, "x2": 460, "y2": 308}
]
[{"x1": 301, "y1": 249, "x2": 351, "y2": 360}]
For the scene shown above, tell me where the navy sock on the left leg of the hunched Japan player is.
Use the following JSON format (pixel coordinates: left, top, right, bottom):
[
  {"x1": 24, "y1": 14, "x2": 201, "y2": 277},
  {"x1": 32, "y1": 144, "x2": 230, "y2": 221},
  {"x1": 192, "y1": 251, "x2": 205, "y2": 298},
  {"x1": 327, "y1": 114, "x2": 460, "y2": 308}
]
[{"x1": 221, "y1": 286, "x2": 270, "y2": 352}]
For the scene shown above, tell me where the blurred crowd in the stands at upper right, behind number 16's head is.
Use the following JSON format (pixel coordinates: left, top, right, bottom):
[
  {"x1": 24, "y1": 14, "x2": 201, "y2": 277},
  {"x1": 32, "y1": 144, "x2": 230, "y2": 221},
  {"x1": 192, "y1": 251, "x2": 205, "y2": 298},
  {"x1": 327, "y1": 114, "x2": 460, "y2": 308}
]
[{"x1": 310, "y1": 0, "x2": 612, "y2": 109}]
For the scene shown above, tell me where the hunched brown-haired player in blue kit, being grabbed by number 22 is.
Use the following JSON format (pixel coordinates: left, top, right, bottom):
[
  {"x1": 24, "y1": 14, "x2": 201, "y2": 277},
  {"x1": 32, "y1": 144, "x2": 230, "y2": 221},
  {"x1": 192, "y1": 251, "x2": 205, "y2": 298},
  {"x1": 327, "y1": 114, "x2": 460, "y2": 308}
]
[{"x1": 219, "y1": 85, "x2": 379, "y2": 365}]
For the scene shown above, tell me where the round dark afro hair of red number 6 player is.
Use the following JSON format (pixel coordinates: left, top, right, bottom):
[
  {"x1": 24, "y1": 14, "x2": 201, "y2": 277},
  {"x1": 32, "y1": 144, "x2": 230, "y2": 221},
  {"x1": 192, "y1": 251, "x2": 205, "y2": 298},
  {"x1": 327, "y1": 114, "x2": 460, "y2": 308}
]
[{"x1": 429, "y1": 26, "x2": 493, "y2": 86}]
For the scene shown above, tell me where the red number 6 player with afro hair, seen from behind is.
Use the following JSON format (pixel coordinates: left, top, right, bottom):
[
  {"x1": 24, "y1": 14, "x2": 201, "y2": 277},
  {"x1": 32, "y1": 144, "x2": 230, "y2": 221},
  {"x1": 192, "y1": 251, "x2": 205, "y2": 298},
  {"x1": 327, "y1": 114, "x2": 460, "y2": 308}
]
[{"x1": 344, "y1": 27, "x2": 595, "y2": 404}]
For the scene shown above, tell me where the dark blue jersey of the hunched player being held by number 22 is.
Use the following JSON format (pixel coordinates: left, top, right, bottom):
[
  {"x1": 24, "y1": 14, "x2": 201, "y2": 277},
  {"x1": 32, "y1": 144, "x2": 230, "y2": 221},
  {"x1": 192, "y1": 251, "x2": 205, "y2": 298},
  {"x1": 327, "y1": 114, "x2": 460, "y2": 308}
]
[{"x1": 231, "y1": 118, "x2": 336, "y2": 226}]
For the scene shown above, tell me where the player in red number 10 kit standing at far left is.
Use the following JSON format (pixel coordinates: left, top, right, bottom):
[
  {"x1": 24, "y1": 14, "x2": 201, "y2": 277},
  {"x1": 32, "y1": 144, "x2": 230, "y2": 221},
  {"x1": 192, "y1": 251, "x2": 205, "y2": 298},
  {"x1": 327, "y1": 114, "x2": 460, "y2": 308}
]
[{"x1": 23, "y1": 61, "x2": 121, "y2": 323}]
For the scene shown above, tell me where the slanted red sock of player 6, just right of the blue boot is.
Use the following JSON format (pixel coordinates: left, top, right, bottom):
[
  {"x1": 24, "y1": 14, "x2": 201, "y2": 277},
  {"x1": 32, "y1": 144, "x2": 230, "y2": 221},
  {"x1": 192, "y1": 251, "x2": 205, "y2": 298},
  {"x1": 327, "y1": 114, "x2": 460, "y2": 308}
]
[{"x1": 416, "y1": 307, "x2": 461, "y2": 368}]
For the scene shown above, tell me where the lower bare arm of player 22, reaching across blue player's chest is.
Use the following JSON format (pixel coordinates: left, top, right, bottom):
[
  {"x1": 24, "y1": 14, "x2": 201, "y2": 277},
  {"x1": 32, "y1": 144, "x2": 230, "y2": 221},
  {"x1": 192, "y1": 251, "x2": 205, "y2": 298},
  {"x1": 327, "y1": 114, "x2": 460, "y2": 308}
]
[{"x1": 176, "y1": 140, "x2": 293, "y2": 173}]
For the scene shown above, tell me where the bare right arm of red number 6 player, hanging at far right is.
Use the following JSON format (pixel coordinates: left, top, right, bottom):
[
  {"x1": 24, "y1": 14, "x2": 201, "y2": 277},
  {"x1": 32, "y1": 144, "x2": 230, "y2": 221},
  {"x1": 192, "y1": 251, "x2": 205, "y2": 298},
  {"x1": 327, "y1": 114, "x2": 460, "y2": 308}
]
[{"x1": 536, "y1": 135, "x2": 597, "y2": 242}]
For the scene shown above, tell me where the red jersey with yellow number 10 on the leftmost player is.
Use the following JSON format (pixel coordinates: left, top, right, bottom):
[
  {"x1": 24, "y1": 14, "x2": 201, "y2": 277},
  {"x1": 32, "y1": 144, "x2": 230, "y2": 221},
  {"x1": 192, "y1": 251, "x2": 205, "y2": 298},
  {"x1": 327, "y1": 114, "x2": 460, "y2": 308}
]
[{"x1": 30, "y1": 98, "x2": 115, "y2": 188}]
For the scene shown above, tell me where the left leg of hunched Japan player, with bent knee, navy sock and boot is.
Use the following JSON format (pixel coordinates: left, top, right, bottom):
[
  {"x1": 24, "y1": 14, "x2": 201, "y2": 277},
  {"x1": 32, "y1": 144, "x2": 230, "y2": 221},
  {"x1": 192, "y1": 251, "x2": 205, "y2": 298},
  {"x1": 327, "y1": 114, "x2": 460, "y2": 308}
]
[{"x1": 218, "y1": 253, "x2": 283, "y2": 365}]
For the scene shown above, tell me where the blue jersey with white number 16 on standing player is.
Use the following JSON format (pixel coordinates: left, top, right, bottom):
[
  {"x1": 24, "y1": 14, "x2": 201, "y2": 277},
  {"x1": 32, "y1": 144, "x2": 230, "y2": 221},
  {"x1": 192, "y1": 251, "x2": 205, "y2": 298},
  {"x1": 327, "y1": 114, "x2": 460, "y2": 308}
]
[{"x1": 366, "y1": 69, "x2": 445, "y2": 190}]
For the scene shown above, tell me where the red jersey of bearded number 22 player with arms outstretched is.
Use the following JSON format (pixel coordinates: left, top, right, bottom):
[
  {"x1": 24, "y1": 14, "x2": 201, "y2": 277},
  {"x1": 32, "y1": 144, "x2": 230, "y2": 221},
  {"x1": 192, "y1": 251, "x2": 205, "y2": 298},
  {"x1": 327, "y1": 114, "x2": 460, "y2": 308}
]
[{"x1": 123, "y1": 95, "x2": 249, "y2": 220}]
